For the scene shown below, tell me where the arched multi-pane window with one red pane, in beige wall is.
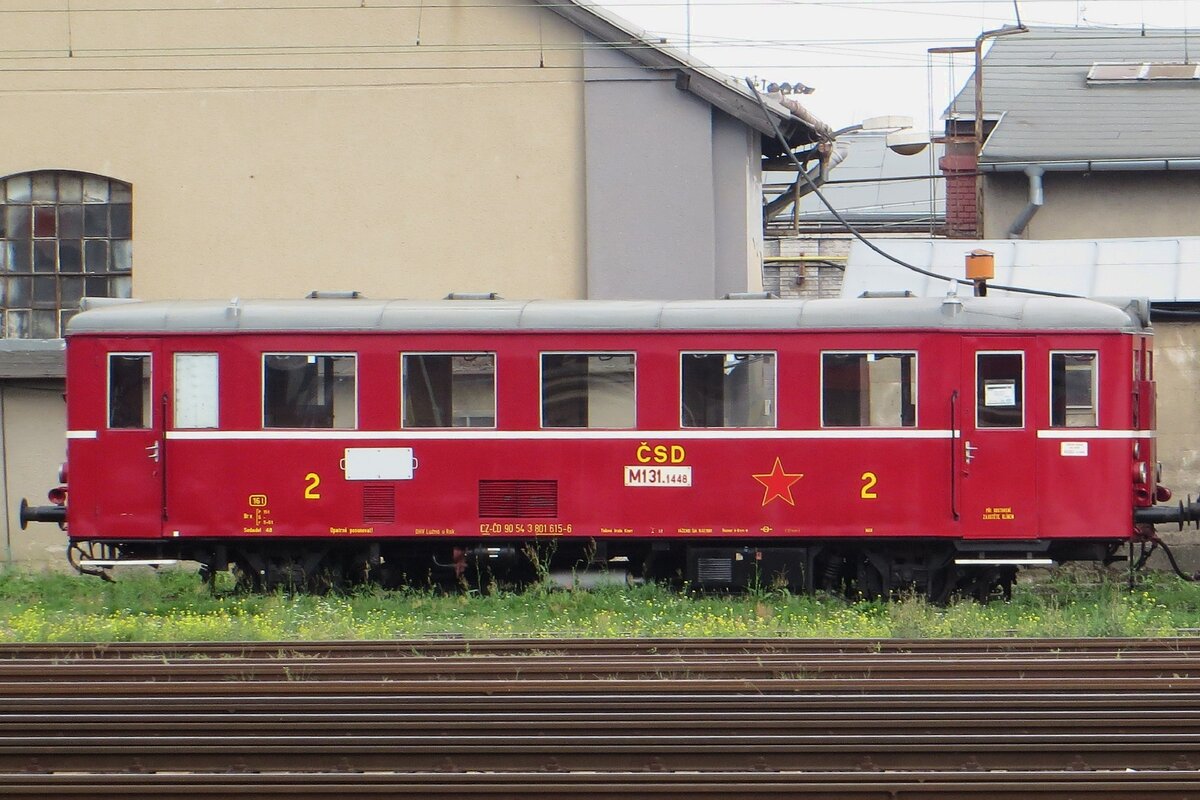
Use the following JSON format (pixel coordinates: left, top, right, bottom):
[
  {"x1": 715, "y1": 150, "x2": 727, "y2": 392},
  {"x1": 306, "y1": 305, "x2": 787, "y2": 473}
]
[{"x1": 0, "y1": 170, "x2": 133, "y2": 339}]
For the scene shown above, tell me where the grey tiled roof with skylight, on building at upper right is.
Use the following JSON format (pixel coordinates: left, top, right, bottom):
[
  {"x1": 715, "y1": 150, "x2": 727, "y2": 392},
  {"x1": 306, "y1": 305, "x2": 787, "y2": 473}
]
[{"x1": 947, "y1": 28, "x2": 1200, "y2": 162}]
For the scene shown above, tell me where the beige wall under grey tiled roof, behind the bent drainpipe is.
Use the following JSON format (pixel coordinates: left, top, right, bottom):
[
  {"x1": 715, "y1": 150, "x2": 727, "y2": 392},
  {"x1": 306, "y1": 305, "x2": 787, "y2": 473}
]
[{"x1": 980, "y1": 172, "x2": 1200, "y2": 239}]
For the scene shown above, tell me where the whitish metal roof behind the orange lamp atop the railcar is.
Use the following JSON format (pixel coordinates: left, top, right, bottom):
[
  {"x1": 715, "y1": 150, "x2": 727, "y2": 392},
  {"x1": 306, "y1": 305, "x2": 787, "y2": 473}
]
[{"x1": 841, "y1": 236, "x2": 1200, "y2": 302}]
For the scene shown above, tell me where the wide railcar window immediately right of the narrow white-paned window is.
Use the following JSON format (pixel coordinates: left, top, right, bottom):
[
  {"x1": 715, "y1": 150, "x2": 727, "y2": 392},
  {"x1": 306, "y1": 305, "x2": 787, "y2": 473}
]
[{"x1": 263, "y1": 354, "x2": 355, "y2": 428}]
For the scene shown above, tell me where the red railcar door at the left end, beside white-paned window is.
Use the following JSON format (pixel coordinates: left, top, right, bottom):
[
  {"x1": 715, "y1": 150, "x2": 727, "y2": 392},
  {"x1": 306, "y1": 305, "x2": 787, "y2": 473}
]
[{"x1": 96, "y1": 339, "x2": 166, "y2": 537}]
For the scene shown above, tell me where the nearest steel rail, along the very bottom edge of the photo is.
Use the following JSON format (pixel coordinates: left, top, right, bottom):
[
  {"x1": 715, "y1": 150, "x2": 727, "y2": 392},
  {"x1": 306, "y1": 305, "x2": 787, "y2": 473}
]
[{"x1": 0, "y1": 770, "x2": 1200, "y2": 800}]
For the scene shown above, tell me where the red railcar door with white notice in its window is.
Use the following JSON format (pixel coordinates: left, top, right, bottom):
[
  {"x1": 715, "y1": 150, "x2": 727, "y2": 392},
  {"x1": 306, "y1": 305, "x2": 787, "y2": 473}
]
[{"x1": 953, "y1": 337, "x2": 1037, "y2": 539}]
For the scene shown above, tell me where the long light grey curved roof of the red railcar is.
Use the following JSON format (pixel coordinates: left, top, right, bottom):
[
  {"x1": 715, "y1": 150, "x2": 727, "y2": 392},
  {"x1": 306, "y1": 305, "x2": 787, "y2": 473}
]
[{"x1": 67, "y1": 296, "x2": 1148, "y2": 336}]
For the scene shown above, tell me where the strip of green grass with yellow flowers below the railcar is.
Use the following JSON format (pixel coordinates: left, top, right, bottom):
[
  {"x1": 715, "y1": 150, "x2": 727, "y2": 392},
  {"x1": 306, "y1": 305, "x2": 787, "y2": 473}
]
[{"x1": 0, "y1": 570, "x2": 1200, "y2": 642}]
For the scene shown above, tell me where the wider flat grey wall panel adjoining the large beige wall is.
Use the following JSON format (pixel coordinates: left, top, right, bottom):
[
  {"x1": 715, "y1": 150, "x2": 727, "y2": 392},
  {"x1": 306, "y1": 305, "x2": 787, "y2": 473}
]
[{"x1": 583, "y1": 41, "x2": 716, "y2": 300}]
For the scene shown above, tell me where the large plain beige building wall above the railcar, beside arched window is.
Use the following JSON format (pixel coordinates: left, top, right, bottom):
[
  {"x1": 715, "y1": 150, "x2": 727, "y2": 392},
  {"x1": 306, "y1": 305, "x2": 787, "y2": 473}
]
[{"x1": 0, "y1": 0, "x2": 586, "y2": 299}]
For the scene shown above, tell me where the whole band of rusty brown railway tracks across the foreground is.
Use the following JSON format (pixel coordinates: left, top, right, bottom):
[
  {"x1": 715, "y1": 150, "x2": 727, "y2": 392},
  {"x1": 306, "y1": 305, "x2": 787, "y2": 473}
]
[{"x1": 0, "y1": 639, "x2": 1200, "y2": 800}]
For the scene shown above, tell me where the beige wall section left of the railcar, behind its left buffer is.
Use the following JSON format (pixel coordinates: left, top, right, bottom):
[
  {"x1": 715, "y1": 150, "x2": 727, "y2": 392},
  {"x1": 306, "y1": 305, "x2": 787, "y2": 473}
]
[{"x1": 0, "y1": 380, "x2": 66, "y2": 567}]
